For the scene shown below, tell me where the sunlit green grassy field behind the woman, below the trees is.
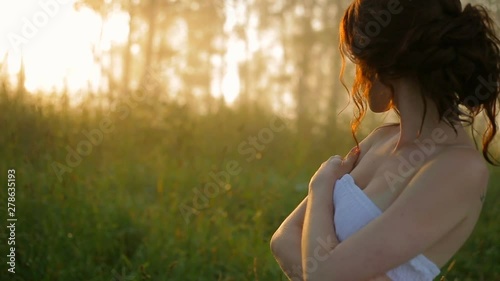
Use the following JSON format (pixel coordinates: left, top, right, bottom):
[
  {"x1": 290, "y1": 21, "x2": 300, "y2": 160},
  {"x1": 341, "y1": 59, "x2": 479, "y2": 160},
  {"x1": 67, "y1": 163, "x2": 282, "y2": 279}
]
[{"x1": 0, "y1": 89, "x2": 500, "y2": 281}]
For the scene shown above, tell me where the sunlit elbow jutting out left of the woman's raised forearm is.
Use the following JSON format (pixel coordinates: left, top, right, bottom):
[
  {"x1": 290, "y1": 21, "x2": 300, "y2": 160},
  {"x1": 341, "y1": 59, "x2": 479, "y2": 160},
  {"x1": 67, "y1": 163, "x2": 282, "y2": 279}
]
[{"x1": 271, "y1": 197, "x2": 307, "y2": 280}]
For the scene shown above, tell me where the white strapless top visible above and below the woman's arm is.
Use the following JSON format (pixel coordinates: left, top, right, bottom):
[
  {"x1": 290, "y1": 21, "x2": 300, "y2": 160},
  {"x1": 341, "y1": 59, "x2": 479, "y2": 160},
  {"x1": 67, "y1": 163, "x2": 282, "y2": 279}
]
[{"x1": 333, "y1": 174, "x2": 440, "y2": 281}]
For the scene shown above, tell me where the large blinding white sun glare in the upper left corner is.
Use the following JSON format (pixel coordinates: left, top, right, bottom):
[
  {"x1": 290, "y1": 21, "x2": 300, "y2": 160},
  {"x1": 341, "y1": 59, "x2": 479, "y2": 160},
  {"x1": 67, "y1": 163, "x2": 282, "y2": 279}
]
[{"x1": 0, "y1": 0, "x2": 128, "y2": 93}]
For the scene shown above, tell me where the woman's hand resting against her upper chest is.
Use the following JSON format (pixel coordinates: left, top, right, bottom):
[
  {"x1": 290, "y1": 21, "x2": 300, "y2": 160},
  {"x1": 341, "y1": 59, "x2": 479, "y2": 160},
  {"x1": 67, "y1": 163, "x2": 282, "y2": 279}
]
[{"x1": 309, "y1": 147, "x2": 359, "y2": 192}]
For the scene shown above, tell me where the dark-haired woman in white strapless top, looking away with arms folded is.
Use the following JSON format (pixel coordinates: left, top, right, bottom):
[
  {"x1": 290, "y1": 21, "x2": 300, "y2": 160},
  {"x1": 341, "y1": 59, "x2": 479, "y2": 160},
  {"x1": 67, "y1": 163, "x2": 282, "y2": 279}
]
[{"x1": 271, "y1": 0, "x2": 500, "y2": 281}]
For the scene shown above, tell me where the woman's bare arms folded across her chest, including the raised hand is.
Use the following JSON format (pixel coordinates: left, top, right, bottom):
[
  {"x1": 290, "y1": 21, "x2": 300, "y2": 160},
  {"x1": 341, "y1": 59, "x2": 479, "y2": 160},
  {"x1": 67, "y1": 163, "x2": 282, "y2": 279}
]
[{"x1": 271, "y1": 148, "x2": 488, "y2": 281}]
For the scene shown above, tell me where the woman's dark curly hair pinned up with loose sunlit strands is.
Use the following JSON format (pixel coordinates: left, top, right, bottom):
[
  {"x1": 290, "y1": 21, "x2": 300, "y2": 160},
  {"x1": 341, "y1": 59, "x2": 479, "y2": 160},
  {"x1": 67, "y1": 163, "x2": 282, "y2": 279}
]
[{"x1": 340, "y1": 0, "x2": 500, "y2": 164}]
